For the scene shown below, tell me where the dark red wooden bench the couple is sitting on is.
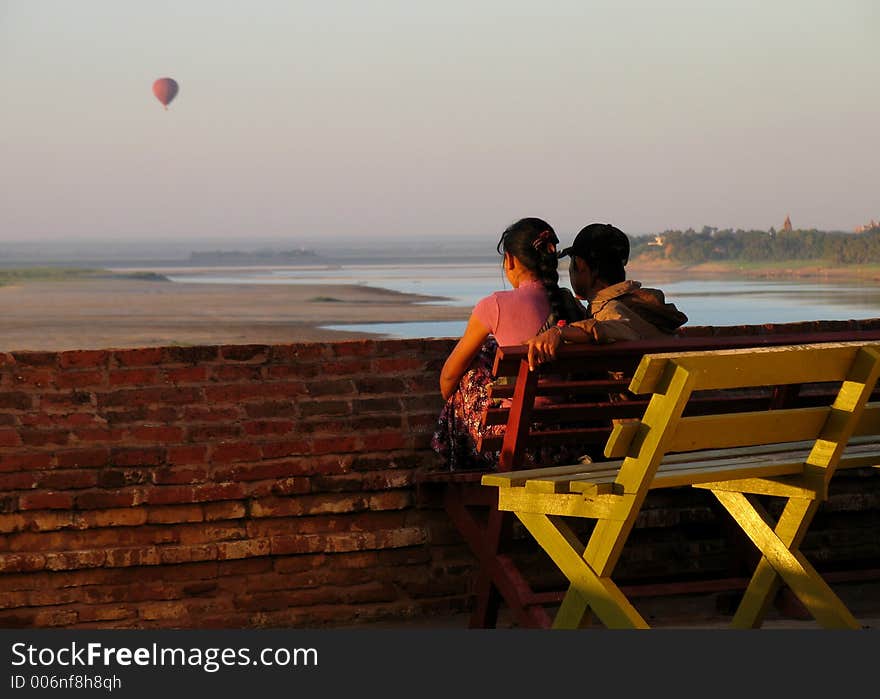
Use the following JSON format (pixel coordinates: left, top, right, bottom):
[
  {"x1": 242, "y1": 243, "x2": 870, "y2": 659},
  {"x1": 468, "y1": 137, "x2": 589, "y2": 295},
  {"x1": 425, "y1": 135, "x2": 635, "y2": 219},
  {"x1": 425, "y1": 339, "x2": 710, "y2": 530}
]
[{"x1": 417, "y1": 323, "x2": 880, "y2": 628}]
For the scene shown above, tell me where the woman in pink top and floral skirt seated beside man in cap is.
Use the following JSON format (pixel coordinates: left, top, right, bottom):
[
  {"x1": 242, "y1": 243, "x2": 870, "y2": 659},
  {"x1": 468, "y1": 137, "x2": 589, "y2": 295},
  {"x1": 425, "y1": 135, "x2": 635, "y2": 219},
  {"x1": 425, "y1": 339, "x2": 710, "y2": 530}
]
[{"x1": 432, "y1": 218, "x2": 587, "y2": 471}]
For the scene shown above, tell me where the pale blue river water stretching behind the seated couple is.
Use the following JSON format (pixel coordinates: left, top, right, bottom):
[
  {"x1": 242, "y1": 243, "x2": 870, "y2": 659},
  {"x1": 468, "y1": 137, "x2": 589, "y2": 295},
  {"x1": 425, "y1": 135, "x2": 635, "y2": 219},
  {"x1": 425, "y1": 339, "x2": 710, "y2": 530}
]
[{"x1": 162, "y1": 262, "x2": 880, "y2": 338}]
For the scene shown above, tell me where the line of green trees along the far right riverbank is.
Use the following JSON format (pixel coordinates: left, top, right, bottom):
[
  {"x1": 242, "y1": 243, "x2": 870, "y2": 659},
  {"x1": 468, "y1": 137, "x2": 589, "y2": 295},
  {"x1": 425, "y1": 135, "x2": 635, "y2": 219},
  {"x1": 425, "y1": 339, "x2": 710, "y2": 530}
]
[{"x1": 630, "y1": 226, "x2": 880, "y2": 265}]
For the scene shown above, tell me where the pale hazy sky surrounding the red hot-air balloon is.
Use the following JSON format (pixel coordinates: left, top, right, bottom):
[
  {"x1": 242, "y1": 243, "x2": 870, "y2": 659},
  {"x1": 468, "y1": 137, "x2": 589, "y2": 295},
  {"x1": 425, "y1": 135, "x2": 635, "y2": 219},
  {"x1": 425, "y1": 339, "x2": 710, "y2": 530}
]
[{"x1": 0, "y1": 0, "x2": 880, "y2": 241}]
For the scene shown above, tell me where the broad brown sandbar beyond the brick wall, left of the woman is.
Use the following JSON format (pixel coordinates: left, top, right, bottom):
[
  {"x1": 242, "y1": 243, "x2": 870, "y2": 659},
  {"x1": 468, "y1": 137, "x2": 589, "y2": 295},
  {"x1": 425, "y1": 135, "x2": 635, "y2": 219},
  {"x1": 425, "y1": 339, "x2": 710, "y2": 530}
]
[{"x1": 0, "y1": 277, "x2": 470, "y2": 352}]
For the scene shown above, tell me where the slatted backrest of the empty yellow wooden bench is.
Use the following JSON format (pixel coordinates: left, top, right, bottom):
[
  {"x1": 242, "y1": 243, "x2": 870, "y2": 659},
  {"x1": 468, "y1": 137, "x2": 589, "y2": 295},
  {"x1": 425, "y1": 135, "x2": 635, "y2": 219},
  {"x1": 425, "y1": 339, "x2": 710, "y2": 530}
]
[{"x1": 605, "y1": 342, "x2": 880, "y2": 493}]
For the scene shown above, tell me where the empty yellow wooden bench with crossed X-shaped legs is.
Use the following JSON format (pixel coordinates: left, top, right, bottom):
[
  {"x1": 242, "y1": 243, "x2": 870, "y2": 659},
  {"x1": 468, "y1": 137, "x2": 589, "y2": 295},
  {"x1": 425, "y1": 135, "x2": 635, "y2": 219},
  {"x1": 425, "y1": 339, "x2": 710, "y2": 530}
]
[{"x1": 482, "y1": 342, "x2": 880, "y2": 628}]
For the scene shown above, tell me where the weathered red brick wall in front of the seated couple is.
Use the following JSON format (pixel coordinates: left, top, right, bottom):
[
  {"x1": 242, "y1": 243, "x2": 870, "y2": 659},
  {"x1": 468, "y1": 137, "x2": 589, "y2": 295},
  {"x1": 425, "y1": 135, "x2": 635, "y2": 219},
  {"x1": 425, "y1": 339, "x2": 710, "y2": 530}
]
[{"x1": 0, "y1": 320, "x2": 880, "y2": 628}]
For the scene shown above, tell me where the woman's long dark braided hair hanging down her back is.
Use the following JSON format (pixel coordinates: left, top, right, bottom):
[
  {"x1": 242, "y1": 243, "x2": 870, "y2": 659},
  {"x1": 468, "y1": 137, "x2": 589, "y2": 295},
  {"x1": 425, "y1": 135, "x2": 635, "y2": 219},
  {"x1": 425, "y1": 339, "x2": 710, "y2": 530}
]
[{"x1": 496, "y1": 218, "x2": 584, "y2": 321}]
